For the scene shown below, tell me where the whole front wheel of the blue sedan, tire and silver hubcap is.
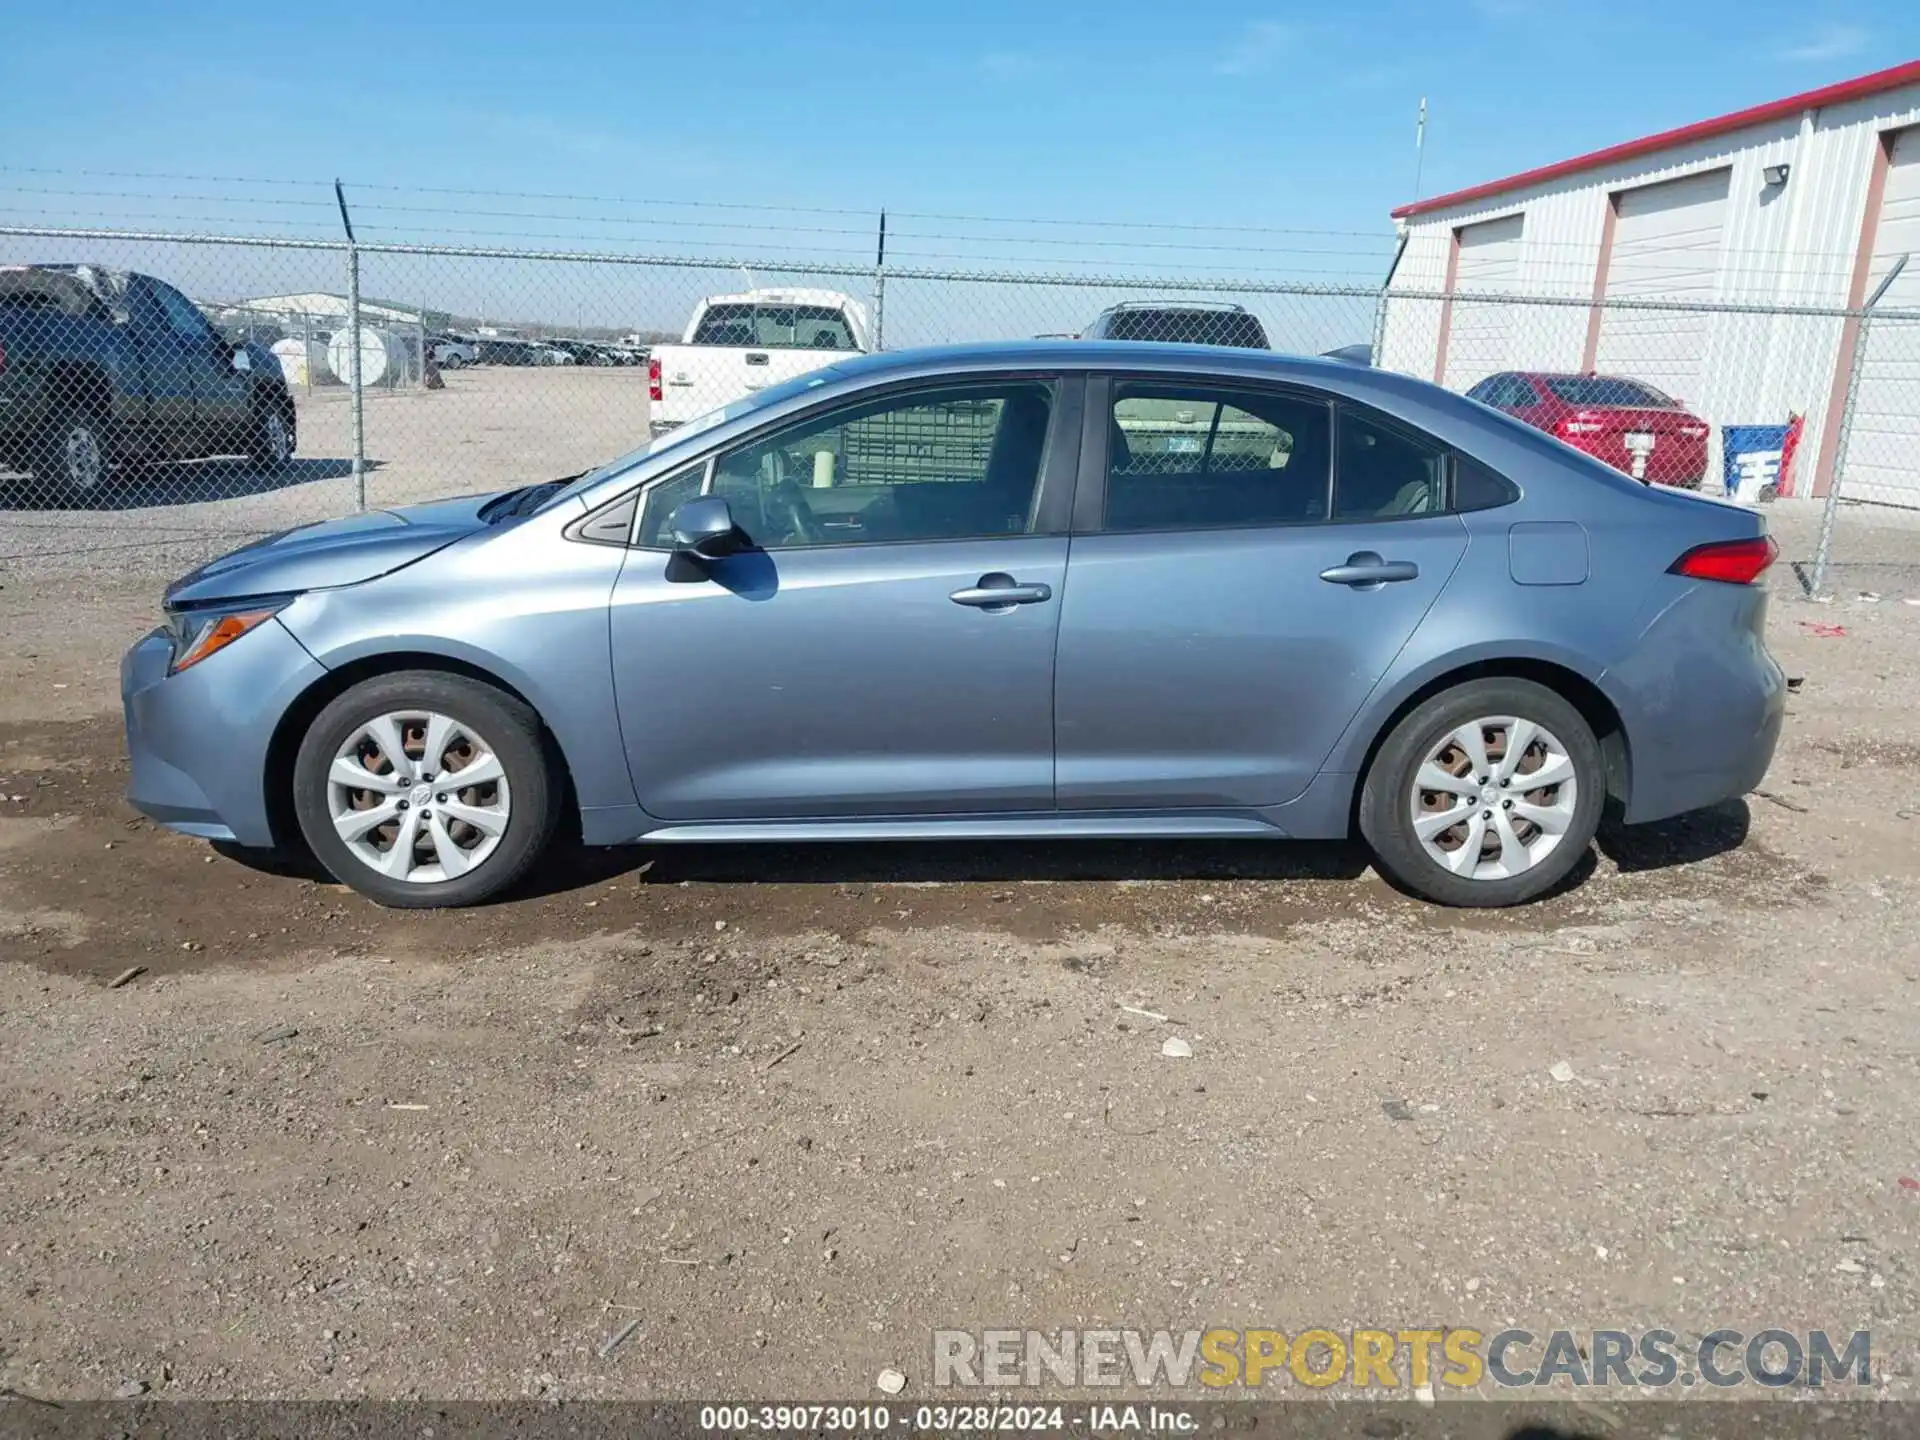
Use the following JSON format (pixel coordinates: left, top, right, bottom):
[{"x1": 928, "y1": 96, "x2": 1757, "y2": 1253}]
[{"x1": 294, "y1": 670, "x2": 561, "y2": 908}]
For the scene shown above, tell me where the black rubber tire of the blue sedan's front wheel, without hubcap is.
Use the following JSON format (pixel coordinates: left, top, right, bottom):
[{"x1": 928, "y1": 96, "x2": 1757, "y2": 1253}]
[{"x1": 294, "y1": 670, "x2": 561, "y2": 910}]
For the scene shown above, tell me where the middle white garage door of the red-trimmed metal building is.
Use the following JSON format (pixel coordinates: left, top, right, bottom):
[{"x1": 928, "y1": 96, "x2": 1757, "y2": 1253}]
[{"x1": 1594, "y1": 171, "x2": 1732, "y2": 414}]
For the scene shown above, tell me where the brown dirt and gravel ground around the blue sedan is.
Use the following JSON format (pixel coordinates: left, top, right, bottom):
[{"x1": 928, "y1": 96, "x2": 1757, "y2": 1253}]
[{"x1": 0, "y1": 474, "x2": 1920, "y2": 1400}]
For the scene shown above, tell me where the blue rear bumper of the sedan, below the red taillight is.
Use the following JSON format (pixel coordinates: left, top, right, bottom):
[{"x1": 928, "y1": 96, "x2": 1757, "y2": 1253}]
[{"x1": 1605, "y1": 580, "x2": 1788, "y2": 824}]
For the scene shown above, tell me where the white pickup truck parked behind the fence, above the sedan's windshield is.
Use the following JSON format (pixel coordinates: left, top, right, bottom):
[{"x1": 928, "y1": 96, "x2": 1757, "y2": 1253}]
[{"x1": 647, "y1": 290, "x2": 868, "y2": 436}]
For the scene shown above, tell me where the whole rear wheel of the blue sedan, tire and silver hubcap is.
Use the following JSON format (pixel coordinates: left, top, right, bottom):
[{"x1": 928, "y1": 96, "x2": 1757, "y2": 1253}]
[{"x1": 1359, "y1": 680, "x2": 1607, "y2": 906}]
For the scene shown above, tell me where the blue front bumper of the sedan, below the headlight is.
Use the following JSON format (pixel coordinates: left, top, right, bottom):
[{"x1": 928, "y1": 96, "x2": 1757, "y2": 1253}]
[{"x1": 121, "y1": 620, "x2": 326, "y2": 847}]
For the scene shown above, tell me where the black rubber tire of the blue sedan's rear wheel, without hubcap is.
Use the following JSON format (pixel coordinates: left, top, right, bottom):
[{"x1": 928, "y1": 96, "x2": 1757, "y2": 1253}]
[{"x1": 1359, "y1": 680, "x2": 1607, "y2": 906}]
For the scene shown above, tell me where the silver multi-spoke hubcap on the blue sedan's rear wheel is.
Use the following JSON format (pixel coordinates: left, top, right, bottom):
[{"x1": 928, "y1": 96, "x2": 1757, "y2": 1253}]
[{"x1": 1409, "y1": 714, "x2": 1580, "y2": 879}]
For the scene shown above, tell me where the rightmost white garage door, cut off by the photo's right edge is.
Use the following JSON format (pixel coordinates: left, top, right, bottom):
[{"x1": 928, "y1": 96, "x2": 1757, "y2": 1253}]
[{"x1": 1839, "y1": 127, "x2": 1920, "y2": 507}]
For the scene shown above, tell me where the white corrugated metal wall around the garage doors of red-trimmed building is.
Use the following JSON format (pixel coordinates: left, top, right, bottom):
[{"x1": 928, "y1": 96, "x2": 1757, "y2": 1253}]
[{"x1": 1379, "y1": 86, "x2": 1920, "y2": 493}]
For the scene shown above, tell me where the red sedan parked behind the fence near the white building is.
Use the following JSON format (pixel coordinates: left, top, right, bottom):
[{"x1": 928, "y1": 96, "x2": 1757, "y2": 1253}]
[{"x1": 1467, "y1": 371, "x2": 1713, "y2": 490}]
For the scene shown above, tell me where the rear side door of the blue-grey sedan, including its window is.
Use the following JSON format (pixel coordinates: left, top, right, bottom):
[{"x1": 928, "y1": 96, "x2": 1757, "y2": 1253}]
[{"x1": 1054, "y1": 376, "x2": 1467, "y2": 810}]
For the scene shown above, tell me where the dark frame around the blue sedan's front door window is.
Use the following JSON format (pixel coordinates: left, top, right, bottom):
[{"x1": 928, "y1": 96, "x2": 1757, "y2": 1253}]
[{"x1": 614, "y1": 369, "x2": 1091, "y2": 555}]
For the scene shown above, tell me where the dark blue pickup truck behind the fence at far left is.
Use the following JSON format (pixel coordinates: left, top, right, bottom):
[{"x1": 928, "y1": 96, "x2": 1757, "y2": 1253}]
[{"x1": 0, "y1": 265, "x2": 294, "y2": 499}]
